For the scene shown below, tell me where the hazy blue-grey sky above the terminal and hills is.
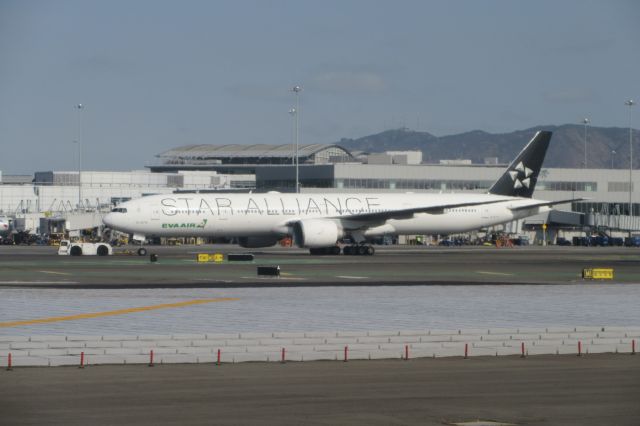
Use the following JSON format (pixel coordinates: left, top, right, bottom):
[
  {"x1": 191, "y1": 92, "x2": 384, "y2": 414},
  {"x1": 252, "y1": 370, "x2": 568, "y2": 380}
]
[{"x1": 0, "y1": 0, "x2": 640, "y2": 174}]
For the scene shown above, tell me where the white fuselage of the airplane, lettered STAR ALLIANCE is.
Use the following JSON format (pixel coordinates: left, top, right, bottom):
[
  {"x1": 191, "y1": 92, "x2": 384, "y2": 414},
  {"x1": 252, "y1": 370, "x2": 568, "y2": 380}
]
[{"x1": 104, "y1": 193, "x2": 548, "y2": 237}]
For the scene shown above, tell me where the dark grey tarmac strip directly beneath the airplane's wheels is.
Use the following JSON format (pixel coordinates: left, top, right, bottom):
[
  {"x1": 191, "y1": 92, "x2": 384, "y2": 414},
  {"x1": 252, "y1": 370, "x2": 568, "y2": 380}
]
[{"x1": 0, "y1": 245, "x2": 640, "y2": 288}]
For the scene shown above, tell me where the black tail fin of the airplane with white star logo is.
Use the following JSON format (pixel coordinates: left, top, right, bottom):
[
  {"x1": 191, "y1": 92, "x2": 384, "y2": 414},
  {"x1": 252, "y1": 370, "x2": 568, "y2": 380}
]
[{"x1": 489, "y1": 131, "x2": 551, "y2": 198}]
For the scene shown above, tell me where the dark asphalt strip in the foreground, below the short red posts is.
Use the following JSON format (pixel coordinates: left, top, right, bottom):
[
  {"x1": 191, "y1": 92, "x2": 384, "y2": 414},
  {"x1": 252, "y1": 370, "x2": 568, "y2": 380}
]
[{"x1": 0, "y1": 355, "x2": 640, "y2": 425}]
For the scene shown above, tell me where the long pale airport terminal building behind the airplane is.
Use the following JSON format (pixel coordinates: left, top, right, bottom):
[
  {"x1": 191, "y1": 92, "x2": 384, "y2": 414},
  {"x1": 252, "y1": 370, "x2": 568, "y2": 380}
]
[{"x1": 0, "y1": 144, "x2": 640, "y2": 233}]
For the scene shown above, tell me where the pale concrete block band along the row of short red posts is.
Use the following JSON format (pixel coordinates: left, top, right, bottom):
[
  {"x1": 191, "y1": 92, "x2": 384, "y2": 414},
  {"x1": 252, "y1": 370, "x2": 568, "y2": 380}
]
[{"x1": 0, "y1": 326, "x2": 640, "y2": 366}]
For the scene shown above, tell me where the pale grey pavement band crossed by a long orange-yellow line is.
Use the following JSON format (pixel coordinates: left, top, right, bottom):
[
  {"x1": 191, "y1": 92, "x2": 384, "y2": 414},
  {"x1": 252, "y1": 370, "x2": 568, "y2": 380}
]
[{"x1": 0, "y1": 284, "x2": 640, "y2": 336}]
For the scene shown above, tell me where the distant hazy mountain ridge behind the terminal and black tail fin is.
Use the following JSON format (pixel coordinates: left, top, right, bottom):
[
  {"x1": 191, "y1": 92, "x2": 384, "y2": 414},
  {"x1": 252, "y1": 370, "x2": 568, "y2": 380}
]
[{"x1": 337, "y1": 124, "x2": 640, "y2": 169}]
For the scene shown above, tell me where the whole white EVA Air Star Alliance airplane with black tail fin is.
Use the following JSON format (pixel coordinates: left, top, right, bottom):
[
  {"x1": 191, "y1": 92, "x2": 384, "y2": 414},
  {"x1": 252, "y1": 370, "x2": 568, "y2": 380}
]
[{"x1": 103, "y1": 131, "x2": 577, "y2": 255}]
